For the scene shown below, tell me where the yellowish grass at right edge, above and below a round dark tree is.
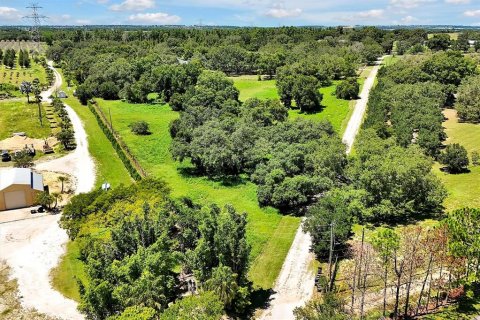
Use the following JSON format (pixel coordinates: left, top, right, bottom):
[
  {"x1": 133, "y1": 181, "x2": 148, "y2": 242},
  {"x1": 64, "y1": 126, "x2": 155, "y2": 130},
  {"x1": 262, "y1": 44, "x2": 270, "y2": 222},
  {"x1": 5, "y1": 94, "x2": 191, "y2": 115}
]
[{"x1": 434, "y1": 109, "x2": 480, "y2": 211}]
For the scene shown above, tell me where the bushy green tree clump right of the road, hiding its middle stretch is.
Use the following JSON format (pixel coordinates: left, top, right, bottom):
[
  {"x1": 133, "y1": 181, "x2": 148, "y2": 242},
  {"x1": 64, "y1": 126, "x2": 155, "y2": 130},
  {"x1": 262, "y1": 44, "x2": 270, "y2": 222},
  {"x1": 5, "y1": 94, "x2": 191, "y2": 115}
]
[{"x1": 349, "y1": 131, "x2": 446, "y2": 221}]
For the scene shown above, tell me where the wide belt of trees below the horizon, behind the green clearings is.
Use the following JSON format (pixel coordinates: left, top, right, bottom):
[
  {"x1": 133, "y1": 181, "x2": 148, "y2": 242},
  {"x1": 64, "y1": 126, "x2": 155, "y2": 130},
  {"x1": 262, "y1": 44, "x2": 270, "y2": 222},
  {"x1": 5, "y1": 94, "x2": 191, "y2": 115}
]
[{"x1": 47, "y1": 28, "x2": 393, "y2": 105}]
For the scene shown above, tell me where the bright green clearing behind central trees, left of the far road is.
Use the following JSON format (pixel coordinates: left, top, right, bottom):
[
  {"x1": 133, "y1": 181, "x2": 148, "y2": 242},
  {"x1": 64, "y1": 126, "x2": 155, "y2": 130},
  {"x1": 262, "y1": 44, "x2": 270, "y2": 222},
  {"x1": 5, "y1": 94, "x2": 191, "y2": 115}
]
[{"x1": 231, "y1": 67, "x2": 371, "y2": 134}]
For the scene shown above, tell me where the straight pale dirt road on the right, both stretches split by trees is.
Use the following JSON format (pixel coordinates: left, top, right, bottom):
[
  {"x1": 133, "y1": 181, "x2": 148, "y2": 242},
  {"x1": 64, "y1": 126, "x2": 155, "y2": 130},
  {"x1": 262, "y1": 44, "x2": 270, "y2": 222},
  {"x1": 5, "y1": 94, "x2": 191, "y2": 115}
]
[{"x1": 260, "y1": 58, "x2": 383, "y2": 320}]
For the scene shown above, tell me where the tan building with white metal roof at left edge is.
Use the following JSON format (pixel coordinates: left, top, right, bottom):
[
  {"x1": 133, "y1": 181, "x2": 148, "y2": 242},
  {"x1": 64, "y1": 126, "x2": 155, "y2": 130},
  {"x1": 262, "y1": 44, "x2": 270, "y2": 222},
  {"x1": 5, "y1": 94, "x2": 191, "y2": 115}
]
[{"x1": 0, "y1": 168, "x2": 44, "y2": 211}]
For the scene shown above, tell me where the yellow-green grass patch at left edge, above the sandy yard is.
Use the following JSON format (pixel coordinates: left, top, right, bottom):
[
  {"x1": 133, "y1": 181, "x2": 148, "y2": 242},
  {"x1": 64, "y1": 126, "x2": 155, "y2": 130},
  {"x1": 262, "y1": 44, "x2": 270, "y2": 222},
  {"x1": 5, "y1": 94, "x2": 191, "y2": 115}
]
[{"x1": 0, "y1": 101, "x2": 52, "y2": 140}]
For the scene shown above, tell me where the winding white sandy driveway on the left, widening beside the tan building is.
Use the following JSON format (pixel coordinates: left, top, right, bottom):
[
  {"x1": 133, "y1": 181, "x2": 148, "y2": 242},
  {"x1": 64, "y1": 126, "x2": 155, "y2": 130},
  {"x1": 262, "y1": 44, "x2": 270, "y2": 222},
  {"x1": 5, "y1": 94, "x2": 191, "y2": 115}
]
[{"x1": 0, "y1": 62, "x2": 95, "y2": 320}]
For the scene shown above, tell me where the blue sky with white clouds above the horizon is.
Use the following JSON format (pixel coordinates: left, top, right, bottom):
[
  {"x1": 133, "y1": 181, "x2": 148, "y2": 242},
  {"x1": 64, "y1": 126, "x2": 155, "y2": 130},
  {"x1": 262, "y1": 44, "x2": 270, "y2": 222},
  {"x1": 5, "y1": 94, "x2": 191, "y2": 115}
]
[{"x1": 0, "y1": 0, "x2": 480, "y2": 26}]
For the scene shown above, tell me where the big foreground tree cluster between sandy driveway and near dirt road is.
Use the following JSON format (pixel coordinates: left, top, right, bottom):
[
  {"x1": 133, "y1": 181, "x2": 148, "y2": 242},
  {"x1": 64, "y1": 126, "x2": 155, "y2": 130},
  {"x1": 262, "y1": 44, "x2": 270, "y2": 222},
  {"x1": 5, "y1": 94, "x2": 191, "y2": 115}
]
[{"x1": 61, "y1": 179, "x2": 251, "y2": 320}]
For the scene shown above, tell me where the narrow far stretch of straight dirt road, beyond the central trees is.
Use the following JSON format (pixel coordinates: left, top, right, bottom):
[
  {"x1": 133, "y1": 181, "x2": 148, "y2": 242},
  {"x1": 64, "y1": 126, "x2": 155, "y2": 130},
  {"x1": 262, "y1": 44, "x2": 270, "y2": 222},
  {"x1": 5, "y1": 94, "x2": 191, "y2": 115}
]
[{"x1": 343, "y1": 57, "x2": 385, "y2": 153}]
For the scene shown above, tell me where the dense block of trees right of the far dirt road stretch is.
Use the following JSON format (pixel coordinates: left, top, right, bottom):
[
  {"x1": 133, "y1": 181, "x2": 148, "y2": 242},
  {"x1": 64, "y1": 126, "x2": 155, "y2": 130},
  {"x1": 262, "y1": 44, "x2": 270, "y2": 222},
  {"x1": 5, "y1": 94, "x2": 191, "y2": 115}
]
[{"x1": 364, "y1": 51, "x2": 477, "y2": 157}]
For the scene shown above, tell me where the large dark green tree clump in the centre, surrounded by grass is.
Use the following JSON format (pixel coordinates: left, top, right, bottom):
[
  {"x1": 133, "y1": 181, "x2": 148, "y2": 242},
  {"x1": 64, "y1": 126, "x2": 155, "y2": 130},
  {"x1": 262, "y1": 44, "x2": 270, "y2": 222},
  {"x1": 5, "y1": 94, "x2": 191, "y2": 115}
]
[{"x1": 170, "y1": 71, "x2": 346, "y2": 210}]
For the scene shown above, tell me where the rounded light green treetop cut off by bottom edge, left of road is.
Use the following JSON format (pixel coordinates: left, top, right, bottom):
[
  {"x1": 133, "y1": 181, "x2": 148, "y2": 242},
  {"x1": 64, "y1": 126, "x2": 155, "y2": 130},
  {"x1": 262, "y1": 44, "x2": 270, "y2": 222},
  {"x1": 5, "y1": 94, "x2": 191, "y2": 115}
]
[{"x1": 159, "y1": 291, "x2": 224, "y2": 320}]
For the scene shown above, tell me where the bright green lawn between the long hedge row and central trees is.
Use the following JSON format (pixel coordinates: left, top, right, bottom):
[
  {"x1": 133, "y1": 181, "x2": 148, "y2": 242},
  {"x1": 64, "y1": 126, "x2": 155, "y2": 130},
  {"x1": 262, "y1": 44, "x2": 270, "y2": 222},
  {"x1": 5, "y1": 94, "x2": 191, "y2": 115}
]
[{"x1": 97, "y1": 99, "x2": 300, "y2": 288}]
